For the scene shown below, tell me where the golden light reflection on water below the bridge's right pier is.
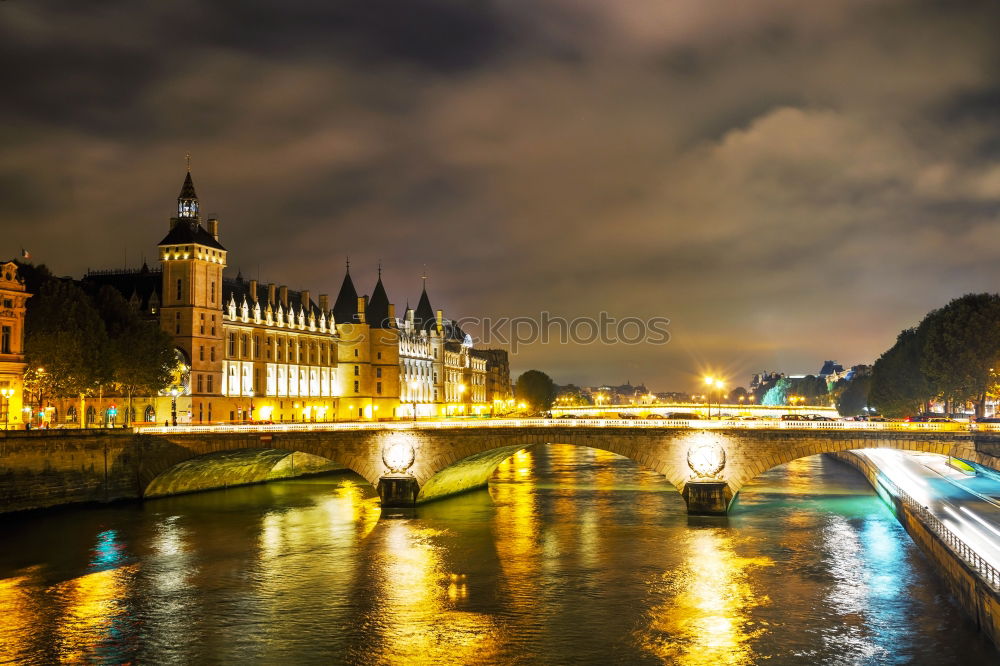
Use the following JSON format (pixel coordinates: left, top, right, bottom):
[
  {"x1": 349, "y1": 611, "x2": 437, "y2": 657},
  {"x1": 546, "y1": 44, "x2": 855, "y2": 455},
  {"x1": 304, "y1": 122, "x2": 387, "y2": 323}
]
[{"x1": 638, "y1": 529, "x2": 773, "y2": 666}]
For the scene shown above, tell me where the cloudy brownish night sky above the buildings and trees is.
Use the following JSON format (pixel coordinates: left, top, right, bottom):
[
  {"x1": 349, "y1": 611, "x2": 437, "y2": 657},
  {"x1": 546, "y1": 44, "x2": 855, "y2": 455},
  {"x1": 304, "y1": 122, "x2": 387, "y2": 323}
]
[{"x1": 0, "y1": 0, "x2": 1000, "y2": 390}]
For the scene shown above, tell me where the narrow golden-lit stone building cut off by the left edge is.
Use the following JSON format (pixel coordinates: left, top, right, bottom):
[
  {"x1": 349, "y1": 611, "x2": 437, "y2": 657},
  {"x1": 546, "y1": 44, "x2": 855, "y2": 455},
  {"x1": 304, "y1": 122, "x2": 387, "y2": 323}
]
[{"x1": 0, "y1": 261, "x2": 31, "y2": 428}]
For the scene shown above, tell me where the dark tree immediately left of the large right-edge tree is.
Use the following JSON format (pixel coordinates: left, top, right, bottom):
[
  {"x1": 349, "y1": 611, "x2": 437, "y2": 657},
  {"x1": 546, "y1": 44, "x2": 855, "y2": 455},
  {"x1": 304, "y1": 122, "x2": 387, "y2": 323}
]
[{"x1": 869, "y1": 319, "x2": 934, "y2": 416}]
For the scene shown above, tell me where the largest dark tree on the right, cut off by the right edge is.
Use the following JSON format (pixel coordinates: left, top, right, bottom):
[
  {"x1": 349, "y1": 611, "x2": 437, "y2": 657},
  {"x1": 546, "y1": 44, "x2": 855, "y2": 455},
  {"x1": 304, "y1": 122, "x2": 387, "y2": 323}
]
[{"x1": 920, "y1": 294, "x2": 1000, "y2": 416}]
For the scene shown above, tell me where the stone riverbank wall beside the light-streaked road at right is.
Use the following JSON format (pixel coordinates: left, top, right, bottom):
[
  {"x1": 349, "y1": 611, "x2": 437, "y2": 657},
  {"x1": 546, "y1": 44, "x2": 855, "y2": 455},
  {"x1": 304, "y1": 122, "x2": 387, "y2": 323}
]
[{"x1": 825, "y1": 451, "x2": 1000, "y2": 649}]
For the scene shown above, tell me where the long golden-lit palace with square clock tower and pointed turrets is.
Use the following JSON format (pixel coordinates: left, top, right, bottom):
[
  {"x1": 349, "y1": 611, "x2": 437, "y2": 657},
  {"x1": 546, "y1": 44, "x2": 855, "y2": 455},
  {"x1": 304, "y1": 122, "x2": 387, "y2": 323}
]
[{"x1": 72, "y1": 172, "x2": 500, "y2": 423}]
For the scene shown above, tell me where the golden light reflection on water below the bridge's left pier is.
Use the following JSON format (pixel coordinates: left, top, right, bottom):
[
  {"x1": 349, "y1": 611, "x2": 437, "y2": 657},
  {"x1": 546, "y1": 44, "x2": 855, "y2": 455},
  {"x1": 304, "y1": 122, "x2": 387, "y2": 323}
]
[{"x1": 372, "y1": 520, "x2": 505, "y2": 664}]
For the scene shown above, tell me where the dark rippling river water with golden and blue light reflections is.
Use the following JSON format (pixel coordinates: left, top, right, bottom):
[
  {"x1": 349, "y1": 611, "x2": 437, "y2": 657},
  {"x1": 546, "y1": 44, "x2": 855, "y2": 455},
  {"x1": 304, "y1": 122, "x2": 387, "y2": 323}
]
[{"x1": 0, "y1": 445, "x2": 998, "y2": 665}]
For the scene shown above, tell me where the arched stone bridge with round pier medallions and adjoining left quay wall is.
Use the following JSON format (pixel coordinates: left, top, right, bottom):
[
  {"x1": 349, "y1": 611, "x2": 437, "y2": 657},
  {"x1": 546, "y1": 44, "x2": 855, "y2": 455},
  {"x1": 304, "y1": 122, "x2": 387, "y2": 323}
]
[{"x1": 0, "y1": 421, "x2": 1000, "y2": 514}]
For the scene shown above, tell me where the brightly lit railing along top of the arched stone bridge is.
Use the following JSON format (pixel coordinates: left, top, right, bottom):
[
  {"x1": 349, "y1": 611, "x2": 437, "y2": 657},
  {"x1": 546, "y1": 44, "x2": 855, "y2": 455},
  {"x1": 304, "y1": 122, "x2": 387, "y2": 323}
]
[{"x1": 134, "y1": 418, "x2": 976, "y2": 435}]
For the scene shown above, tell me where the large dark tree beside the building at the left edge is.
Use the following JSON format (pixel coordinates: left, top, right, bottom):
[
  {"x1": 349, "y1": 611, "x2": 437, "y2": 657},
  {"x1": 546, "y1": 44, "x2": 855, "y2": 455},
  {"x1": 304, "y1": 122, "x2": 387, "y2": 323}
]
[{"x1": 24, "y1": 280, "x2": 108, "y2": 396}]
